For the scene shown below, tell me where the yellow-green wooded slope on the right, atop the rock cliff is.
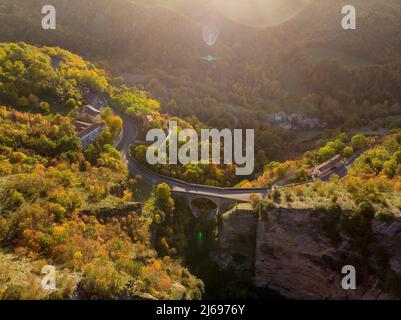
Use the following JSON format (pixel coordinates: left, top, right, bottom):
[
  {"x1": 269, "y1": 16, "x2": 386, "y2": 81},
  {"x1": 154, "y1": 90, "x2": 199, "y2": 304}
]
[{"x1": 256, "y1": 130, "x2": 401, "y2": 205}]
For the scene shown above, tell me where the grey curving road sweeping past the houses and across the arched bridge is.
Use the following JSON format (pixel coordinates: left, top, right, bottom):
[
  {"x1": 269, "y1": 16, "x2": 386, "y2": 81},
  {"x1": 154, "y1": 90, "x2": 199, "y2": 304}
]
[{"x1": 114, "y1": 111, "x2": 269, "y2": 202}]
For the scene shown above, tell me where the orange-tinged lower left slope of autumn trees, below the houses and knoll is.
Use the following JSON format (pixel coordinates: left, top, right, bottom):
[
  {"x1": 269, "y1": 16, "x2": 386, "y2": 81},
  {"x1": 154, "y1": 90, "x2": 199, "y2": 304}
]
[{"x1": 0, "y1": 108, "x2": 203, "y2": 299}]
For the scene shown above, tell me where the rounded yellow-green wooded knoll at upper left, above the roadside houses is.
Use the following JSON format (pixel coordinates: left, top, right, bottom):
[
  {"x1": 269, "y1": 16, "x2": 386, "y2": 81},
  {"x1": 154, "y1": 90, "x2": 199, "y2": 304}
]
[{"x1": 0, "y1": 43, "x2": 108, "y2": 114}]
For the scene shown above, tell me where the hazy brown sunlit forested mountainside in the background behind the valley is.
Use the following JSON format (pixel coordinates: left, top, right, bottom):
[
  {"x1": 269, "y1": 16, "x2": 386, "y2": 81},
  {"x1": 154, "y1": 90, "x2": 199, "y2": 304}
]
[{"x1": 0, "y1": 0, "x2": 401, "y2": 160}]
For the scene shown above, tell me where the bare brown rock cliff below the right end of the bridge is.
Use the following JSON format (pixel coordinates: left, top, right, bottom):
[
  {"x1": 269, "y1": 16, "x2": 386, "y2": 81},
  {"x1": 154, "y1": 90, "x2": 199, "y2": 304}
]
[{"x1": 218, "y1": 207, "x2": 401, "y2": 299}]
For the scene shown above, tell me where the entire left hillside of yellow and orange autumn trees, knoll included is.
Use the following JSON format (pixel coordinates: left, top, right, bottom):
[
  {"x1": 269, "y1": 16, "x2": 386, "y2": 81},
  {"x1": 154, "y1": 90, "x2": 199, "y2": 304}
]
[{"x1": 0, "y1": 43, "x2": 203, "y2": 299}]
